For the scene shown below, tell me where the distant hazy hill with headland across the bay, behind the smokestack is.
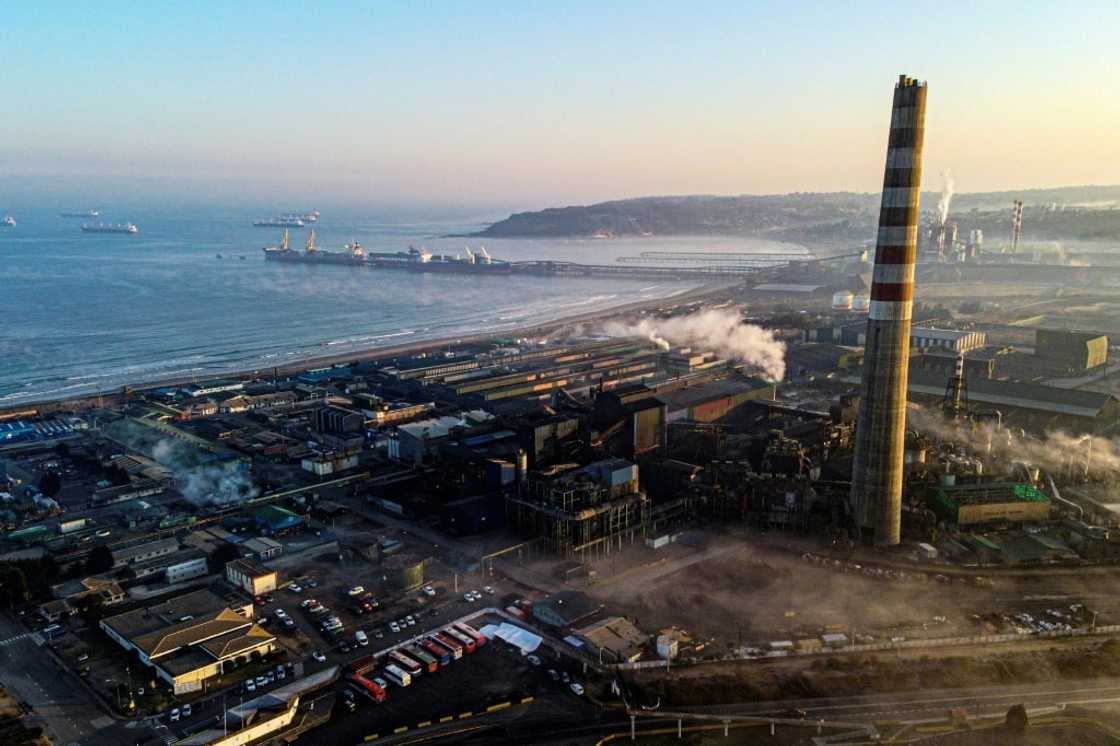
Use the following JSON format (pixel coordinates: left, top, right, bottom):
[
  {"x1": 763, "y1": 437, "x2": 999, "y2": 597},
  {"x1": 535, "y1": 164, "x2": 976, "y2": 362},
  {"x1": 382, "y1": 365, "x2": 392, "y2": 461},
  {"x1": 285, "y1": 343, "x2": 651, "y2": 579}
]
[{"x1": 475, "y1": 186, "x2": 1120, "y2": 241}]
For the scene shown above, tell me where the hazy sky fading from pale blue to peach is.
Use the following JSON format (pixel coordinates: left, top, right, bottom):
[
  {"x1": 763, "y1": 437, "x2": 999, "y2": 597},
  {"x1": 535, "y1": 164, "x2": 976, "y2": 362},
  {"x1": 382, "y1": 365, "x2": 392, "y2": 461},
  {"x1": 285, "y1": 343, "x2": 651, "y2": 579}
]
[{"x1": 0, "y1": 0, "x2": 1120, "y2": 207}]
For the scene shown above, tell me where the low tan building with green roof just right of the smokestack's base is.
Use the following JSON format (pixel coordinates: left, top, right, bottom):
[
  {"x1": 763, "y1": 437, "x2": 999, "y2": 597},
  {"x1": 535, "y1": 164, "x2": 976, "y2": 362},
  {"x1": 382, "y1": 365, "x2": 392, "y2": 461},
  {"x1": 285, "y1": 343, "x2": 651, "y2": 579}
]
[{"x1": 928, "y1": 483, "x2": 1051, "y2": 526}]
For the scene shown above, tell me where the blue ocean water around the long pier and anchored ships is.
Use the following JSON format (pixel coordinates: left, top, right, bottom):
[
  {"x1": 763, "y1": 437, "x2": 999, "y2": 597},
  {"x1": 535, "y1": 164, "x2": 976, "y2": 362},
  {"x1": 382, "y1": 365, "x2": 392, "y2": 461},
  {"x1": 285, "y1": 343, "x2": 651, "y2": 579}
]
[{"x1": 0, "y1": 205, "x2": 806, "y2": 407}]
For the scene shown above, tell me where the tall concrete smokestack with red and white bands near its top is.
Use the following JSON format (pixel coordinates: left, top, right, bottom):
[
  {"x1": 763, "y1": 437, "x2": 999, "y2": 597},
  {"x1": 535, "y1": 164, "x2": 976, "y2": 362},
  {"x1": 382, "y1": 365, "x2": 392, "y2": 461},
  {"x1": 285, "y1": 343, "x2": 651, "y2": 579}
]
[{"x1": 851, "y1": 75, "x2": 926, "y2": 547}]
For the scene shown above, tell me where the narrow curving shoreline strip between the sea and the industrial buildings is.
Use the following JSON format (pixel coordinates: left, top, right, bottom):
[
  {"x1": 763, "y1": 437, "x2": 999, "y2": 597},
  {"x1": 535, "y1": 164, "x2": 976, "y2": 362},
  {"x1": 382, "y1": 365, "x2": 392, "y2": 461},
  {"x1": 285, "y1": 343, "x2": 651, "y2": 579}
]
[{"x1": 0, "y1": 280, "x2": 741, "y2": 419}]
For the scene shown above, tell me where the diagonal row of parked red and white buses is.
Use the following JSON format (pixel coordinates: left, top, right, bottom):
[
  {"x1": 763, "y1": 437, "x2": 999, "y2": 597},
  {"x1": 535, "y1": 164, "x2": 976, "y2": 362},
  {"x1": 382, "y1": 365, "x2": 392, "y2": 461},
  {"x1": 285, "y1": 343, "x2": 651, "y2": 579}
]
[{"x1": 347, "y1": 622, "x2": 486, "y2": 702}]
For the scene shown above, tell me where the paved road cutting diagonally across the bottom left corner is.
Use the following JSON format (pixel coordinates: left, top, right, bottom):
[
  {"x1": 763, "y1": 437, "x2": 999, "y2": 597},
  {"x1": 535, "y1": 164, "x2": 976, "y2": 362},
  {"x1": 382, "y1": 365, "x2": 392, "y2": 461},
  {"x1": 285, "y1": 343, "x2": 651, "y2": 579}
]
[{"x1": 0, "y1": 613, "x2": 157, "y2": 745}]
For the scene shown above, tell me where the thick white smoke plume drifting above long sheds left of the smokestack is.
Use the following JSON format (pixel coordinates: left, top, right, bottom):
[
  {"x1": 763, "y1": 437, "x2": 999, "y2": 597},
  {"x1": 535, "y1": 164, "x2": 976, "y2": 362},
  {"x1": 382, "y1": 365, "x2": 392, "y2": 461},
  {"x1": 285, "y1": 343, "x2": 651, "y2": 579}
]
[{"x1": 604, "y1": 308, "x2": 785, "y2": 381}]
